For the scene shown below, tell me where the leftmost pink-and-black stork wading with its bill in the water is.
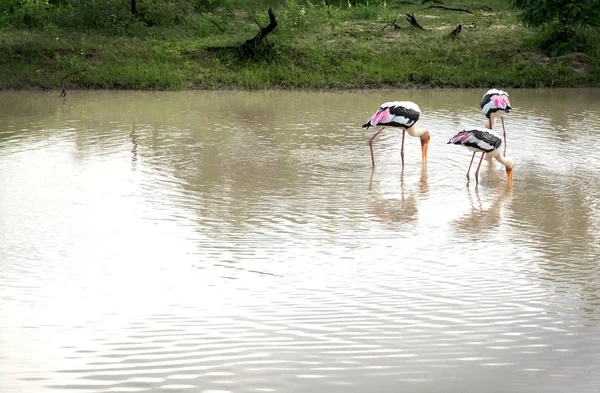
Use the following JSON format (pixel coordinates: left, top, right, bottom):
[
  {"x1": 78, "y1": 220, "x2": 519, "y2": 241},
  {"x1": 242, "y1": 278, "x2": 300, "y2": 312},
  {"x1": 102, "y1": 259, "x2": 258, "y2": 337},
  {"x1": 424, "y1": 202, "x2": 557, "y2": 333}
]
[{"x1": 363, "y1": 101, "x2": 431, "y2": 167}]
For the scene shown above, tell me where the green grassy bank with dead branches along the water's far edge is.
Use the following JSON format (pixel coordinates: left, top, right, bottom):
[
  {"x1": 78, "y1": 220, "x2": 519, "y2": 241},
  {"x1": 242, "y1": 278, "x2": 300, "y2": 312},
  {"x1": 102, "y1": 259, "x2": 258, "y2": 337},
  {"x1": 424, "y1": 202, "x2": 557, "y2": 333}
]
[{"x1": 0, "y1": 0, "x2": 600, "y2": 89}]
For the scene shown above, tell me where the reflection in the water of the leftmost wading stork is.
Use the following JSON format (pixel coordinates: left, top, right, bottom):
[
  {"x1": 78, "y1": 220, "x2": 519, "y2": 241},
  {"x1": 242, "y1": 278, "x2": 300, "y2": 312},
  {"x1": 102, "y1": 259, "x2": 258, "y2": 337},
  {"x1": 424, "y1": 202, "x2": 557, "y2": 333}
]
[{"x1": 369, "y1": 164, "x2": 429, "y2": 223}]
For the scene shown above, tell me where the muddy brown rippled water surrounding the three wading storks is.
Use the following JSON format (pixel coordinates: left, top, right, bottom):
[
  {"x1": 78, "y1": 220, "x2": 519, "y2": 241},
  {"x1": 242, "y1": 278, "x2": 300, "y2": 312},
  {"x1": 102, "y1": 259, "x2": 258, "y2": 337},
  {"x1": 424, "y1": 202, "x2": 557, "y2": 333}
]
[{"x1": 0, "y1": 90, "x2": 600, "y2": 393}]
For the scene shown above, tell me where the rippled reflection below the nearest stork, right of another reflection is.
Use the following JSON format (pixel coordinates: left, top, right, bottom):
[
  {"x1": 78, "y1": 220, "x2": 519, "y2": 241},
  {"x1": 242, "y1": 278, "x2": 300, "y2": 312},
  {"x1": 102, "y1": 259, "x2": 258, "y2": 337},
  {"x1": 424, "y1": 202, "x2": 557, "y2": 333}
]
[{"x1": 454, "y1": 182, "x2": 513, "y2": 235}]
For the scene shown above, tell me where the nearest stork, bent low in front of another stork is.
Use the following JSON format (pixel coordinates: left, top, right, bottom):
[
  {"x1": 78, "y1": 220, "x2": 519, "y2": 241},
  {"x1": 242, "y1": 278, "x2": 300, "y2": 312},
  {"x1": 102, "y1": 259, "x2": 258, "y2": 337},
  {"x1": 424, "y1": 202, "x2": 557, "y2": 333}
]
[{"x1": 448, "y1": 128, "x2": 515, "y2": 183}]
